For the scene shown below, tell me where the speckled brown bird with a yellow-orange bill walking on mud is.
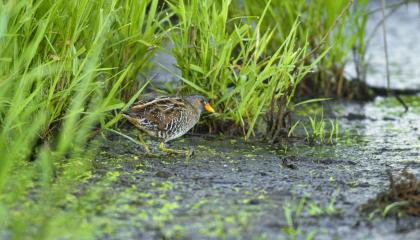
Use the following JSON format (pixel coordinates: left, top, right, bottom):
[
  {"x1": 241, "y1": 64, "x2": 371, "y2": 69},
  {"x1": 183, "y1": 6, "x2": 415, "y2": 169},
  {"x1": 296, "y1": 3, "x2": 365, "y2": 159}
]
[{"x1": 123, "y1": 95, "x2": 215, "y2": 153}]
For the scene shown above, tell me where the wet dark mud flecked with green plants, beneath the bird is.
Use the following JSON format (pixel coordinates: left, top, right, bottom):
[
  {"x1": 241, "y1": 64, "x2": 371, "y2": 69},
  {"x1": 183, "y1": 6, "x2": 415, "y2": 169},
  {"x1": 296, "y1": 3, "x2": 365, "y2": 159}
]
[{"x1": 81, "y1": 96, "x2": 420, "y2": 239}]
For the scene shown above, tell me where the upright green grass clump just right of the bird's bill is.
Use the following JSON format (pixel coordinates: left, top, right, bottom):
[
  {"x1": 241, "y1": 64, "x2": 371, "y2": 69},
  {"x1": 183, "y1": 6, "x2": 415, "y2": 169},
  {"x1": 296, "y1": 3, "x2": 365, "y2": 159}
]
[{"x1": 169, "y1": 0, "x2": 317, "y2": 141}]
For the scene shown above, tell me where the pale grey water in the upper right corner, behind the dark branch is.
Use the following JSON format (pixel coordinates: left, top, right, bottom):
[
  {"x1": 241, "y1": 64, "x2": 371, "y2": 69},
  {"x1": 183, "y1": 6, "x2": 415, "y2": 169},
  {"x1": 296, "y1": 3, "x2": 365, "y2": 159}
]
[{"x1": 346, "y1": 0, "x2": 420, "y2": 89}]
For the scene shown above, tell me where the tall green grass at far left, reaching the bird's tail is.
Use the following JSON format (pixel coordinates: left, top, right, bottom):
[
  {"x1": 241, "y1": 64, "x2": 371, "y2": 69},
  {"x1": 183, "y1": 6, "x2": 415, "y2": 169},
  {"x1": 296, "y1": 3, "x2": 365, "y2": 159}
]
[{"x1": 0, "y1": 0, "x2": 163, "y2": 236}]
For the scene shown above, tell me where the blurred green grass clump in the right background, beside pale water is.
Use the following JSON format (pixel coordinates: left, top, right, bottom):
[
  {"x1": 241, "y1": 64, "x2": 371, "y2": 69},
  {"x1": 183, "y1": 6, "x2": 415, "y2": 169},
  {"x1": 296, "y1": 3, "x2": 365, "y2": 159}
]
[{"x1": 232, "y1": 0, "x2": 368, "y2": 96}]
